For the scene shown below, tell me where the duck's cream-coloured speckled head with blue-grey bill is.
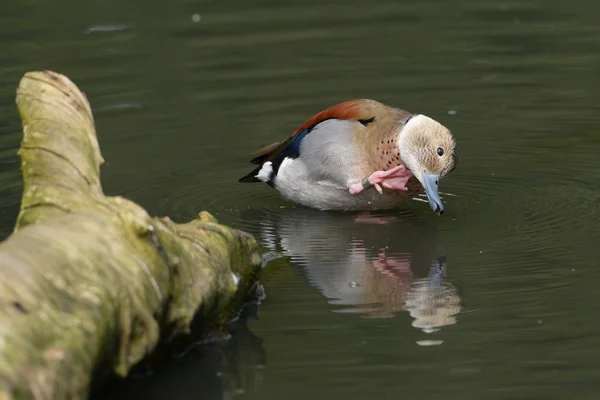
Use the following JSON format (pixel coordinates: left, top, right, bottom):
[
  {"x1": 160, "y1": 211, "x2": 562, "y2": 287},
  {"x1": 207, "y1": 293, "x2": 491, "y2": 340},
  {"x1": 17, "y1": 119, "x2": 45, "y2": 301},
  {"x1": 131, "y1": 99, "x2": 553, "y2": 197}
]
[{"x1": 398, "y1": 114, "x2": 458, "y2": 215}]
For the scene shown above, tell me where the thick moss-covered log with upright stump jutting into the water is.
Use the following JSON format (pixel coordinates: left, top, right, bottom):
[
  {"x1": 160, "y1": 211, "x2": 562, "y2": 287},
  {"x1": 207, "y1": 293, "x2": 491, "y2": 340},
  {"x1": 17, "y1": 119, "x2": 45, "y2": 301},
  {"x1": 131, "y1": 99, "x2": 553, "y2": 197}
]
[{"x1": 0, "y1": 71, "x2": 261, "y2": 400}]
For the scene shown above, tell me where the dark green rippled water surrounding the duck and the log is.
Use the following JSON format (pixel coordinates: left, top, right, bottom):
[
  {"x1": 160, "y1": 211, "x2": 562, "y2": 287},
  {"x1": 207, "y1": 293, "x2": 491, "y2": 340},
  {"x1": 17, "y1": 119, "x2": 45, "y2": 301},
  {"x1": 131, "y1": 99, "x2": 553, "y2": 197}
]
[{"x1": 0, "y1": 0, "x2": 600, "y2": 400}]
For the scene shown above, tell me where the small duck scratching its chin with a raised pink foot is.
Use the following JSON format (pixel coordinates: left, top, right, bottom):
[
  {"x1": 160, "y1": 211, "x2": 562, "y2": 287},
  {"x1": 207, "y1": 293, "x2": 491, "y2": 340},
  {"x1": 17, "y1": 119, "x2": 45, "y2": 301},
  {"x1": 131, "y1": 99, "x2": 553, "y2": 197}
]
[{"x1": 239, "y1": 99, "x2": 459, "y2": 215}]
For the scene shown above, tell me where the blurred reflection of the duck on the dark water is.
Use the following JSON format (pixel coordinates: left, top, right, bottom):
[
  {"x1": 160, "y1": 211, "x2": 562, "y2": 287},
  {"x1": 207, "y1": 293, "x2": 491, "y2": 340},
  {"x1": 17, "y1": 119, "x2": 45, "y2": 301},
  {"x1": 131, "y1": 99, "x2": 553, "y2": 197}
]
[{"x1": 243, "y1": 209, "x2": 461, "y2": 332}]
